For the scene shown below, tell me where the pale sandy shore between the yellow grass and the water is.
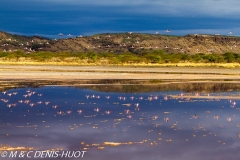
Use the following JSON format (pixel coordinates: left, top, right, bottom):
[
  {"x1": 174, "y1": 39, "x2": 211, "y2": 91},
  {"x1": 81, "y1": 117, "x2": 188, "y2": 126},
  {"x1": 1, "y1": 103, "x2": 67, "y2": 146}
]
[{"x1": 0, "y1": 65, "x2": 240, "y2": 82}]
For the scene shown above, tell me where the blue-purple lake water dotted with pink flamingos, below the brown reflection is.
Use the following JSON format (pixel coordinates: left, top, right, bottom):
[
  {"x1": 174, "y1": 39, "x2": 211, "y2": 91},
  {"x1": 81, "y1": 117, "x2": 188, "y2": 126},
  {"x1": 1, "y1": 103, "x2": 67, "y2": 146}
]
[{"x1": 0, "y1": 84, "x2": 240, "y2": 160}]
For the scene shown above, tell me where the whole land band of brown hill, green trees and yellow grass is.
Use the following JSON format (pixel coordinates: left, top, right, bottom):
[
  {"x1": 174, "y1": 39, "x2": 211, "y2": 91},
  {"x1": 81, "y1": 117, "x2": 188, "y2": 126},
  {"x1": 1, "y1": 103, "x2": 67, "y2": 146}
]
[{"x1": 0, "y1": 32, "x2": 240, "y2": 68}]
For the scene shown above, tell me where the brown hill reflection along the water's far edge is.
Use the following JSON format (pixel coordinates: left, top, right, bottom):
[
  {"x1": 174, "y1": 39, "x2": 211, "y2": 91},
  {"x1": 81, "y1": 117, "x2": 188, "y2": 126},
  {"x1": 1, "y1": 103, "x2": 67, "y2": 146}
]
[{"x1": 0, "y1": 80, "x2": 240, "y2": 93}]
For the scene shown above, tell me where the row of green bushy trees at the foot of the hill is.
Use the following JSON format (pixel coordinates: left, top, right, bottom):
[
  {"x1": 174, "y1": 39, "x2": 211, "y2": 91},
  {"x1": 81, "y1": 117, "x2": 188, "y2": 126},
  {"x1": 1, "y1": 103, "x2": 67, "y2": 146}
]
[{"x1": 0, "y1": 50, "x2": 240, "y2": 64}]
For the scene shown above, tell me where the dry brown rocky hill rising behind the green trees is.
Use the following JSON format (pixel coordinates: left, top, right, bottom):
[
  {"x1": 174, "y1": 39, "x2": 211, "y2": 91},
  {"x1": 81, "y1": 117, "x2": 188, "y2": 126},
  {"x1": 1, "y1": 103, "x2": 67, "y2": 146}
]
[{"x1": 0, "y1": 32, "x2": 240, "y2": 54}]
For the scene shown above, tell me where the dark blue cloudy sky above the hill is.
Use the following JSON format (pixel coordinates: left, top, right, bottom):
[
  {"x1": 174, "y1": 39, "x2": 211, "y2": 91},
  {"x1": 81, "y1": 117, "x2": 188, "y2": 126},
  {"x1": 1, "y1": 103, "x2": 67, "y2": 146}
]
[{"x1": 0, "y1": 0, "x2": 240, "y2": 37}]
